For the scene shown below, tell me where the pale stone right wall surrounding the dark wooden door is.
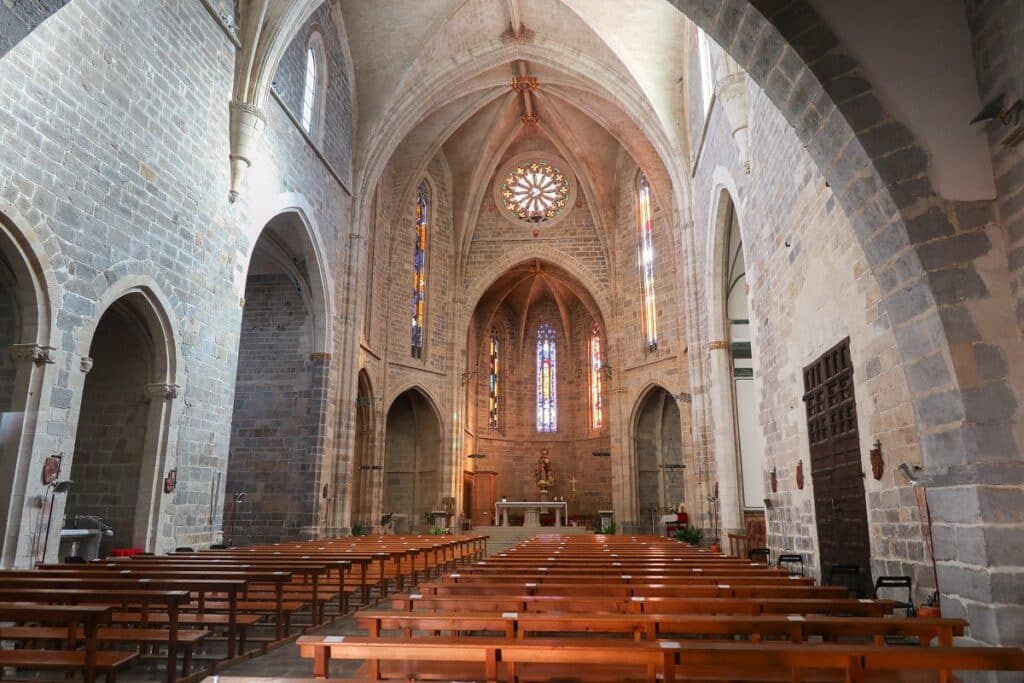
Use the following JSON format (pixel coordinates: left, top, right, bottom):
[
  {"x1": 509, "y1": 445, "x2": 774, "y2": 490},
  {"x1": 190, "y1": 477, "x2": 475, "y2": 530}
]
[{"x1": 690, "y1": 61, "x2": 934, "y2": 600}]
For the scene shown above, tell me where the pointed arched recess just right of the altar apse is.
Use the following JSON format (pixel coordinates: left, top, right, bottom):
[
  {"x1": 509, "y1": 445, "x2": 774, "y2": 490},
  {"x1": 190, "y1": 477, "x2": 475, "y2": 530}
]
[{"x1": 633, "y1": 386, "x2": 685, "y2": 533}]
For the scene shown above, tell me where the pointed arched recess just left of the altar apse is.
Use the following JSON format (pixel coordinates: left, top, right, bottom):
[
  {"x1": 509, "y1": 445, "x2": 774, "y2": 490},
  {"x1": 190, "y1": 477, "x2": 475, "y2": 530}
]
[{"x1": 382, "y1": 389, "x2": 441, "y2": 533}]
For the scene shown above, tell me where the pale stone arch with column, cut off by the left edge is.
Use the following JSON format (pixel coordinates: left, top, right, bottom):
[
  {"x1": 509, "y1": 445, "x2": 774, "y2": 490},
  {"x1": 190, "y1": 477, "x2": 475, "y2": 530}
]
[{"x1": 0, "y1": 203, "x2": 57, "y2": 568}]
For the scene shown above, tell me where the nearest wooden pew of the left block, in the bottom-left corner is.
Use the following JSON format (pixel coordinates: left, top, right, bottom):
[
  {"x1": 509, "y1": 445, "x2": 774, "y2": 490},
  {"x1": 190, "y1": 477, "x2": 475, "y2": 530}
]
[{"x1": 0, "y1": 602, "x2": 136, "y2": 683}]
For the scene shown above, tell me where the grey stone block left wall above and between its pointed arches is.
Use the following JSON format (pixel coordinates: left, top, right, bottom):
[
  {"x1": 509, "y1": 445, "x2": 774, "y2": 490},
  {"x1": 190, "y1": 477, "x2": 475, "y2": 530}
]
[{"x1": 0, "y1": 0, "x2": 349, "y2": 563}]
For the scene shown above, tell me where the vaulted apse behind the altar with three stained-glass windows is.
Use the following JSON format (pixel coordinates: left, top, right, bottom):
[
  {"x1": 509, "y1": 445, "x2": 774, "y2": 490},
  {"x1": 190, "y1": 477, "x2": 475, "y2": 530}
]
[{"x1": 466, "y1": 259, "x2": 612, "y2": 525}]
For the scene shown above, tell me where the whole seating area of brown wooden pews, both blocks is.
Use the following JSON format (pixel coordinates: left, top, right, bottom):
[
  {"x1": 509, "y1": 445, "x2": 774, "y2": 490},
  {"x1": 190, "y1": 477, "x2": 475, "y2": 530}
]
[{"x1": 0, "y1": 533, "x2": 1024, "y2": 683}]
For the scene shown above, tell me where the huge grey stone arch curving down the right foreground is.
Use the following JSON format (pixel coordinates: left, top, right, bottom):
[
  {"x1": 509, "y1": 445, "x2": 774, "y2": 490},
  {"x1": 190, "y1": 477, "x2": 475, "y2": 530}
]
[{"x1": 671, "y1": 0, "x2": 987, "y2": 467}]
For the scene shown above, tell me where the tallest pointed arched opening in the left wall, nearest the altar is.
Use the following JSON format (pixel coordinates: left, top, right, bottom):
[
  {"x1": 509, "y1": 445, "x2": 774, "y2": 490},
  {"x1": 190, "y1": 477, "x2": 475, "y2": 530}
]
[{"x1": 224, "y1": 212, "x2": 330, "y2": 546}]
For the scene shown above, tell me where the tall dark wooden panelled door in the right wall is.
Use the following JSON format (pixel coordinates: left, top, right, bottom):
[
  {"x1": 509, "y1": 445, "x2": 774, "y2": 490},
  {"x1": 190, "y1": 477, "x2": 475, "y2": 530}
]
[{"x1": 804, "y1": 338, "x2": 871, "y2": 595}]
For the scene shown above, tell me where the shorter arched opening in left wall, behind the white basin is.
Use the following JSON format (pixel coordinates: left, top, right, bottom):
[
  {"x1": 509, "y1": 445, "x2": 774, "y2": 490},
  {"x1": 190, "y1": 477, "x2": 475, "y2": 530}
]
[{"x1": 65, "y1": 288, "x2": 177, "y2": 556}]
